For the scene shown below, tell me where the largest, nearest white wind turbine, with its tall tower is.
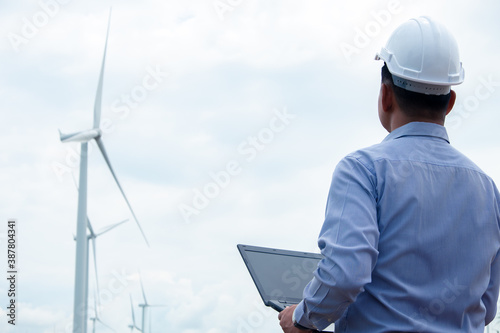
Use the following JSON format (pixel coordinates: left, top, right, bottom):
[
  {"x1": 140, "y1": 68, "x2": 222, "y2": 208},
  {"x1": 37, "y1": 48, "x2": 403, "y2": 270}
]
[{"x1": 59, "y1": 10, "x2": 149, "y2": 333}]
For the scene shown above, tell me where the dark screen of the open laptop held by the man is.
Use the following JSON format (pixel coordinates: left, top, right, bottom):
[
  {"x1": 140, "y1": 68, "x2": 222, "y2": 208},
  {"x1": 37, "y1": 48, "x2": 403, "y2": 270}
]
[{"x1": 238, "y1": 245, "x2": 323, "y2": 303}]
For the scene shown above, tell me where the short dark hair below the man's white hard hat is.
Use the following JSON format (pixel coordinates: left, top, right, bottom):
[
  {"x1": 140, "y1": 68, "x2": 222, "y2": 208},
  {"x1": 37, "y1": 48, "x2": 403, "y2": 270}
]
[{"x1": 382, "y1": 63, "x2": 451, "y2": 119}]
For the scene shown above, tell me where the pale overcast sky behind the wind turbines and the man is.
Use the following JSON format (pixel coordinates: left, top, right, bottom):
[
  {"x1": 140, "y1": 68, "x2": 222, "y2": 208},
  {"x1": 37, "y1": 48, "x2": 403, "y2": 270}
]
[{"x1": 0, "y1": 0, "x2": 500, "y2": 333}]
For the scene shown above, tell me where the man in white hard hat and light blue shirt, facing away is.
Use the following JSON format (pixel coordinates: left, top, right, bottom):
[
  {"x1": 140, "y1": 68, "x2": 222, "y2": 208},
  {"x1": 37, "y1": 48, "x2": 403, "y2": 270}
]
[{"x1": 279, "y1": 17, "x2": 500, "y2": 333}]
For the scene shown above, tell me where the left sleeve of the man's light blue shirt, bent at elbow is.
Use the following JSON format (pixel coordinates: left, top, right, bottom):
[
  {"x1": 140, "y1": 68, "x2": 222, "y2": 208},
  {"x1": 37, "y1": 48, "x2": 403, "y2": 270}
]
[{"x1": 294, "y1": 156, "x2": 379, "y2": 330}]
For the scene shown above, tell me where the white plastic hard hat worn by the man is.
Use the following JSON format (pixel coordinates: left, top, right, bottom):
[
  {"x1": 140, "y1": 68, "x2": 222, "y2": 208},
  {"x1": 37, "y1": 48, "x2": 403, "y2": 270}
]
[{"x1": 375, "y1": 17, "x2": 465, "y2": 95}]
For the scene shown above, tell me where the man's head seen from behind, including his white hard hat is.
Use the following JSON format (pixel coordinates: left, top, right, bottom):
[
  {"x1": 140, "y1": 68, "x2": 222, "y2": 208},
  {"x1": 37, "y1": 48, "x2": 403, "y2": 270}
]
[{"x1": 376, "y1": 17, "x2": 464, "y2": 132}]
